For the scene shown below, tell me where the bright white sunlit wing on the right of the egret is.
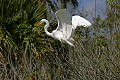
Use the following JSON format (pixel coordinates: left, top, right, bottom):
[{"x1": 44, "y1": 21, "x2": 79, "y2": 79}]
[{"x1": 72, "y1": 15, "x2": 91, "y2": 29}]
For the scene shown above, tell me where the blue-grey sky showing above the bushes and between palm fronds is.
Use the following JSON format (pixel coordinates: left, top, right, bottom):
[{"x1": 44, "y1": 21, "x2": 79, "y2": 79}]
[{"x1": 48, "y1": 0, "x2": 106, "y2": 22}]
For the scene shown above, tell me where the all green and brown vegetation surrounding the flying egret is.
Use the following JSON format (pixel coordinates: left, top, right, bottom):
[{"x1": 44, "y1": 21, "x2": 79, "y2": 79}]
[{"x1": 0, "y1": 0, "x2": 120, "y2": 80}]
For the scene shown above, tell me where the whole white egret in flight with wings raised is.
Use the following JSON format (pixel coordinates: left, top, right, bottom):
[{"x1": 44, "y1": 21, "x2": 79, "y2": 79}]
[{"x1": 35, "y1": 9, "x2": 91, "y2": 46}]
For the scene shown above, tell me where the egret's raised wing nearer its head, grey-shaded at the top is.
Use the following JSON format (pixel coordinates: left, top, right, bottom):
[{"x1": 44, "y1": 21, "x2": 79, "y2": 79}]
[{"x1": 56, "y1": 9, "x2": 72, "y2": 39}]
